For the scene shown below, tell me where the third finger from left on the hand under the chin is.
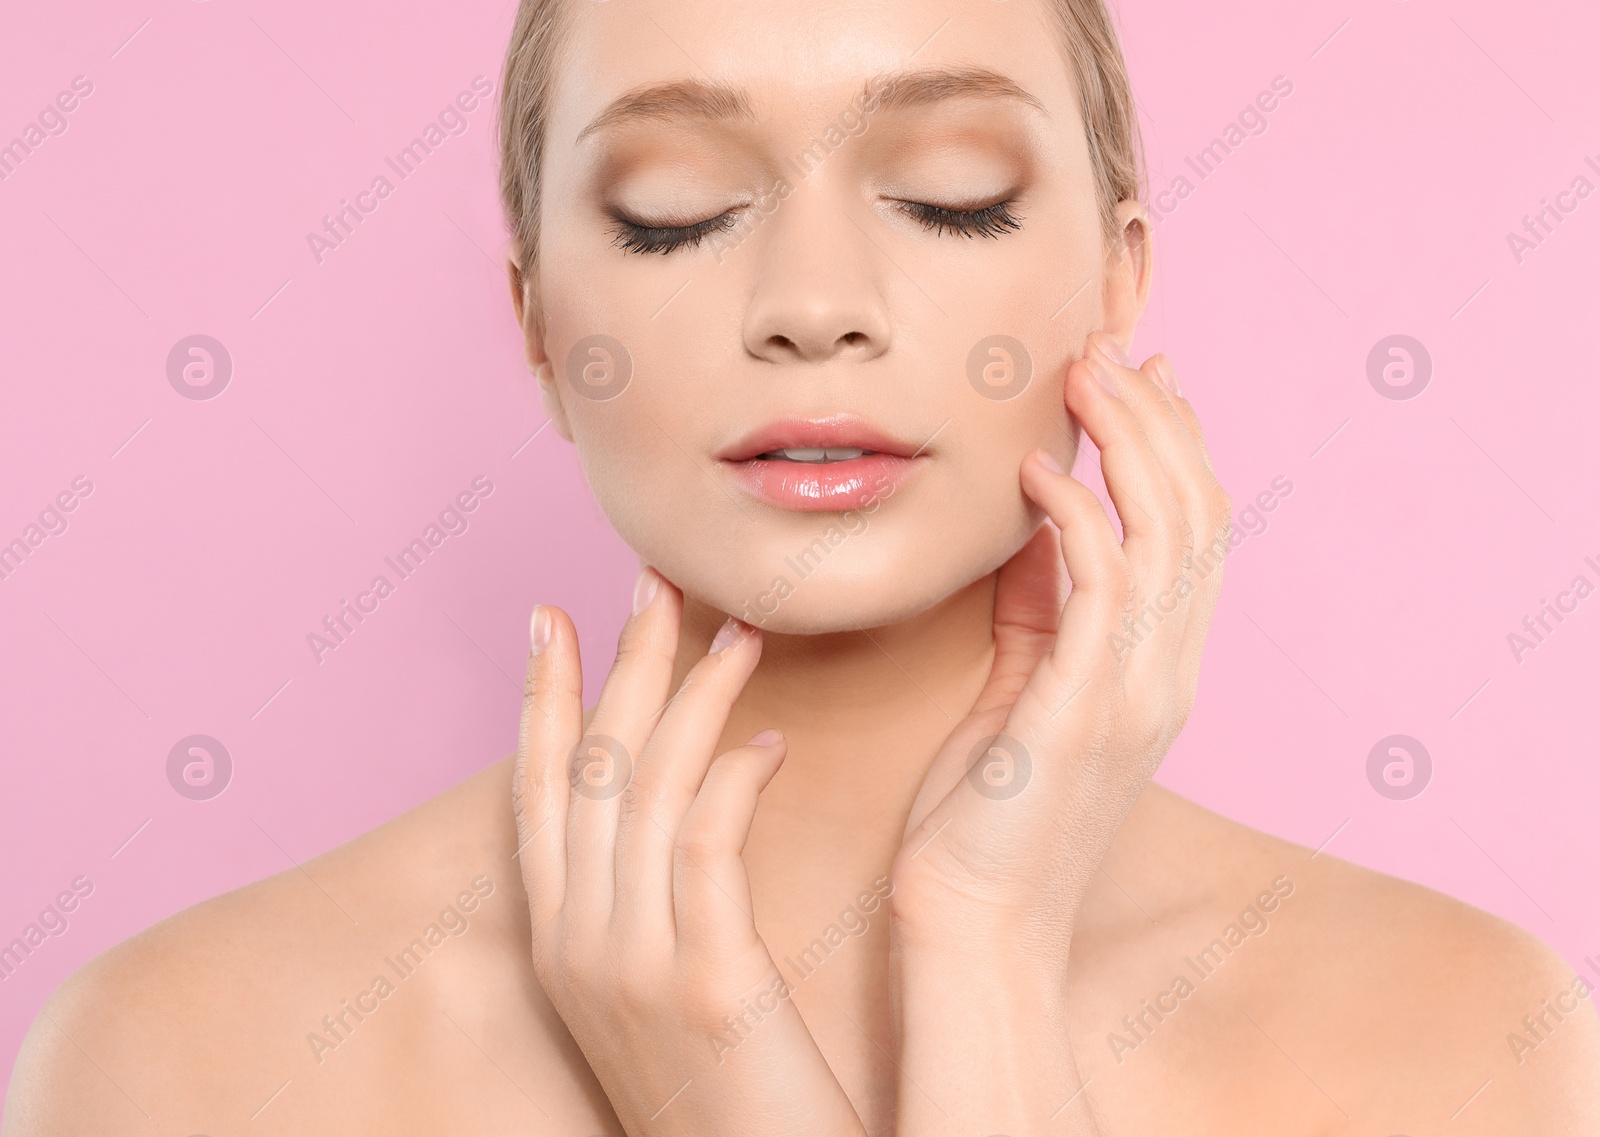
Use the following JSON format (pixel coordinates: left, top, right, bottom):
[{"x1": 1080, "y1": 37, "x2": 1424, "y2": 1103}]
[{"x1": 616, "y1": 619, "x2": 762, "y2": 926}]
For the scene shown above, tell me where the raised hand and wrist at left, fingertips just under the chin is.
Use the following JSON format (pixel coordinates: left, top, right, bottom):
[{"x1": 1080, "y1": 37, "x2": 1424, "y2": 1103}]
[{"x1": 512, "y1": 568, "x2": 864, "y2": 1137}]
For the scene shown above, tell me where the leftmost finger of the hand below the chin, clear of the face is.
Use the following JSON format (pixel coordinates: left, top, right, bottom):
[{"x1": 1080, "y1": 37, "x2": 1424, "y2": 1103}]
[{"x1": 512, "y1": 604, "x2": 582, "y2": 940}]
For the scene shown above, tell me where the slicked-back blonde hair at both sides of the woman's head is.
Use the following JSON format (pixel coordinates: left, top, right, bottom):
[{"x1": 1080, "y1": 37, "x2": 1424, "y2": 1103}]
[{"x1": 499, "y1": 0, "x2": 1144, "y2": 278}]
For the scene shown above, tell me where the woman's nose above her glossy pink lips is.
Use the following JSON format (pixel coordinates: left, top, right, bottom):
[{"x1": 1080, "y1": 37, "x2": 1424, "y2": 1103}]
[{"x1": 744, "y1": 184, "x2": 891, "y2": 363}]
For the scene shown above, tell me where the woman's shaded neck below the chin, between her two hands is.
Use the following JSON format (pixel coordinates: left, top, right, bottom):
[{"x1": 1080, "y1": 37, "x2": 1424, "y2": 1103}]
[{"x1": 675, "y1": 574, "x2": 995, "y2": 867}]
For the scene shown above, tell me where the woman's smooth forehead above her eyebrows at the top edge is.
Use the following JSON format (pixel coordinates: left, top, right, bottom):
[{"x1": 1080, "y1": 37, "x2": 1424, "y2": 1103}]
[{"x1": 547, "y1": 0, "x2": 1078, "y2": 155}]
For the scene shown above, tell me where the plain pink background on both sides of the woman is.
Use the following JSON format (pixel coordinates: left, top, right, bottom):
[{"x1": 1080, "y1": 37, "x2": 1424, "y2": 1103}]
[{"x1": 0, "y1": 0, "x2": 1600, "y2": 1100}]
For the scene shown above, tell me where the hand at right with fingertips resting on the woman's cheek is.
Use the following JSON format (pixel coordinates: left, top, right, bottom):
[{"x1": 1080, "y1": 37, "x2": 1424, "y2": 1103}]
[{"x1": 894, "y1": 333, "x2": 1232, "y2": 963}]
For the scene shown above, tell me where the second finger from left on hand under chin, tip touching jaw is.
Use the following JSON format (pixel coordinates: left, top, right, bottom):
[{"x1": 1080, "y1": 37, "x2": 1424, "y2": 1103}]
[{"x1": 566, "y1": 568, "x2": 683, "y2": 926}]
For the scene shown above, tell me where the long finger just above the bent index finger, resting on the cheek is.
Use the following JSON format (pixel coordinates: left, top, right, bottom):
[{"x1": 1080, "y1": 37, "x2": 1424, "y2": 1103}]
[{"x1": 1066, "y1": 335, "x2": 1182, "y2": 587}]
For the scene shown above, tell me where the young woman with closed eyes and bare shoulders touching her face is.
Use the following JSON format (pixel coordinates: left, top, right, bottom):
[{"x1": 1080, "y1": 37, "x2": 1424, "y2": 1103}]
[{"x1": 6, "y1": 0, "x2": 1600, "y2": 1137}]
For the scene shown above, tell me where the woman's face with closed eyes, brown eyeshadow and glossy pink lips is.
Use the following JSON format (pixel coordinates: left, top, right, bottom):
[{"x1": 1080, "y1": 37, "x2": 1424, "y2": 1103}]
[{"x1": 525, "y1": 0, "x2": 1147, "y2": 633}]
